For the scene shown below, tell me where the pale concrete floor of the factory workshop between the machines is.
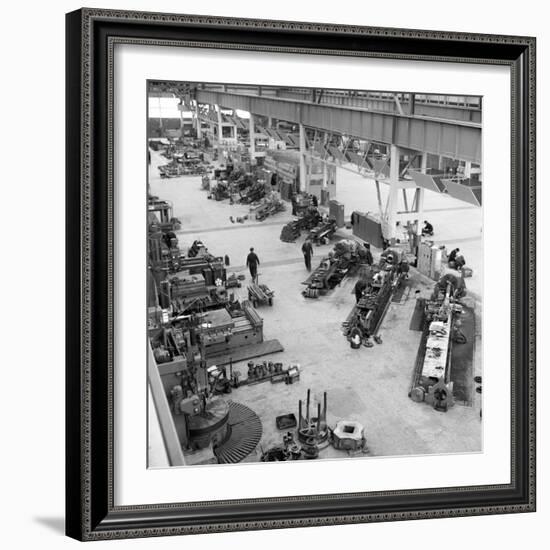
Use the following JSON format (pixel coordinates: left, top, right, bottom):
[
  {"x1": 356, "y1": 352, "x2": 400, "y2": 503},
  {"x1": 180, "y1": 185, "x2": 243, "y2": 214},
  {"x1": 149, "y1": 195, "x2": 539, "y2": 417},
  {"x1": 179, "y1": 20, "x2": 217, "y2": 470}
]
[{"x1": 149, "y1": 152, "x2": 482, "y2": 466}]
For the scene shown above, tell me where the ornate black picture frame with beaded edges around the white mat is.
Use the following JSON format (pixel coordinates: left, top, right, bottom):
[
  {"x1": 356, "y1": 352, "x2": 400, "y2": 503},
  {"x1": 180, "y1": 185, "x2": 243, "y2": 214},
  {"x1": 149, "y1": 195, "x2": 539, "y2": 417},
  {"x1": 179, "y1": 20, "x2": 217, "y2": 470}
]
[{"x1": 66, "y1": 9, "x2": 536, "y2": 540}]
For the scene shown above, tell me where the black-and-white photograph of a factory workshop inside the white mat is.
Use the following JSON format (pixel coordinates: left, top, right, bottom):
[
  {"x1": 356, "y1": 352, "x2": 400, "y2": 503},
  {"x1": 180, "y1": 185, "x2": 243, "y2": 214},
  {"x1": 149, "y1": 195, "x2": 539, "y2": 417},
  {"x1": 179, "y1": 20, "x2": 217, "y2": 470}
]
[{"x1": 146, "y1": 81, "x2": 483, "y2": 468}]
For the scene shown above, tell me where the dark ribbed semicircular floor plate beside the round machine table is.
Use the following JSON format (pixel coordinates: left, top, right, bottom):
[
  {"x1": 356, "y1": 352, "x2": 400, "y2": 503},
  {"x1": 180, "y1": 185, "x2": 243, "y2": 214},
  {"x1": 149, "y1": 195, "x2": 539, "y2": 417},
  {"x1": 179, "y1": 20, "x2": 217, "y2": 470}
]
[{"x1": 214, "y1": 401, "x2": 262, "y2": 464}]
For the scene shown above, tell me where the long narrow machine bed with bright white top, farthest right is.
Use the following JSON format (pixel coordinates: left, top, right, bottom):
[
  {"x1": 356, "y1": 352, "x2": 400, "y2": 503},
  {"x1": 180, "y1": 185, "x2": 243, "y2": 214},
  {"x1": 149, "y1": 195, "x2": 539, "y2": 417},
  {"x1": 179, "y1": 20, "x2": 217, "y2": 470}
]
[{"x1": 409, "y1": 274, "x2": 466, "y2": 411}]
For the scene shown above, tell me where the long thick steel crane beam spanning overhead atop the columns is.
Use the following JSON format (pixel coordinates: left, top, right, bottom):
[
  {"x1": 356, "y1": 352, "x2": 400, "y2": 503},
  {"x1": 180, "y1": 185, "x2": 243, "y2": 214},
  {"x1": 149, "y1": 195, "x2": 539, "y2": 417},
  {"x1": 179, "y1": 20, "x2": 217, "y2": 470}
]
[{"x1": 195, "y1": 89, "x2": 481, "y2": 164}]
